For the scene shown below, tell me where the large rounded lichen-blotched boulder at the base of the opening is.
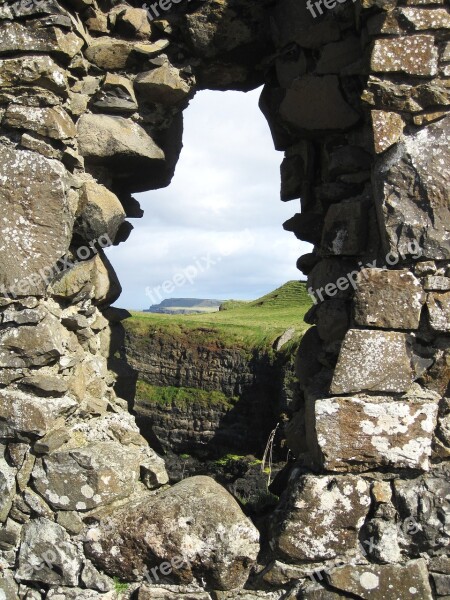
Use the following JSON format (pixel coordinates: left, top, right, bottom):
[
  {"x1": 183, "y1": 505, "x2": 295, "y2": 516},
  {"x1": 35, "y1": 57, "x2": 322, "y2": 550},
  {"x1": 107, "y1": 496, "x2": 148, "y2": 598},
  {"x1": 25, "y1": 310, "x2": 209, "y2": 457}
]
[{"x1": 86, "y1": 476, "x2": 259, "y2": 589}]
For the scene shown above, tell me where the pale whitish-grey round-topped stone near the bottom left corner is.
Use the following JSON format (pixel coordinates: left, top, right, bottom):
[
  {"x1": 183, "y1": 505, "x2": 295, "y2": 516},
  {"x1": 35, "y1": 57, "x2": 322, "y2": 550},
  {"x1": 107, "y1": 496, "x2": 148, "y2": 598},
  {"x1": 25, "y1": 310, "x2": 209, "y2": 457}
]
[{"x1": 16, "y1": 517, "x2": 81, "y2": 586}]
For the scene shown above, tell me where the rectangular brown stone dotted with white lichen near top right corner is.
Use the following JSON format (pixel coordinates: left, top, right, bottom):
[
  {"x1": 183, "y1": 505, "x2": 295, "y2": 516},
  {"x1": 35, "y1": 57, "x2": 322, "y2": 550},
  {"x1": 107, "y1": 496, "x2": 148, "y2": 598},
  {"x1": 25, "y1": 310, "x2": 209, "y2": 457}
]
[{"x1": 371, "y1": 35, "x2": 438, "y2": 77}]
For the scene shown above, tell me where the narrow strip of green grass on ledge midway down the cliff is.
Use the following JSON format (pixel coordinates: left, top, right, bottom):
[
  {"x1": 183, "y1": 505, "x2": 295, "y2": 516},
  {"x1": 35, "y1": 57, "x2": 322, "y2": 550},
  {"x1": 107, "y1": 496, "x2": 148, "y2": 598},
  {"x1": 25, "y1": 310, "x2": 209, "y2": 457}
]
[{"x1": 136, "y1": 379, "x2": 238, "y2": 410}]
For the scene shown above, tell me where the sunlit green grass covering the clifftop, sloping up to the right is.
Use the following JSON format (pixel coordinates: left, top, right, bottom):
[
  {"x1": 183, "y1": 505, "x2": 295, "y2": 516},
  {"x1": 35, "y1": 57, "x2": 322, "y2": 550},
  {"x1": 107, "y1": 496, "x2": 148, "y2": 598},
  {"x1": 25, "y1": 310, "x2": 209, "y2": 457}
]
[{"x1": 124, "y1": 281, "x2": 312, "y2": 349}]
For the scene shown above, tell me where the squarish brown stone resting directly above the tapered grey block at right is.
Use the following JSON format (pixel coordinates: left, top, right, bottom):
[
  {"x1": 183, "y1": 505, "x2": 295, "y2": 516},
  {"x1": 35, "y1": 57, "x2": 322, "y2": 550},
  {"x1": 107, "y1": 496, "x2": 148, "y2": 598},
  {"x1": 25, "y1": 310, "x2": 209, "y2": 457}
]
[{"x1": 354, "y1": 269, "x2": 425, "y2": 329}]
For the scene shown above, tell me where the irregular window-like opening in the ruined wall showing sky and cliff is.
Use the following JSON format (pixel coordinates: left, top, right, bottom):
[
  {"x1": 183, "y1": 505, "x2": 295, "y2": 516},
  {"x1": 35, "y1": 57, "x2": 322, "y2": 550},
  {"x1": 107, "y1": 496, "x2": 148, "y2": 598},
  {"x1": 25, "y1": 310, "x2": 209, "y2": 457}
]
[{"x1": 109, "y1": 90, "x2": 310, "y2": 506}]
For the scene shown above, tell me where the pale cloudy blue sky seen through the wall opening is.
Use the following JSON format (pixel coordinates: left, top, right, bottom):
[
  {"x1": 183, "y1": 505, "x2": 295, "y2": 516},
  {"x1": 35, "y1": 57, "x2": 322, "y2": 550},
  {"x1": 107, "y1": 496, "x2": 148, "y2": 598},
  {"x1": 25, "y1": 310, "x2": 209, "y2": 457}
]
[{"x1": 107, "y1": 90, "x2": 310, "y2": 310}]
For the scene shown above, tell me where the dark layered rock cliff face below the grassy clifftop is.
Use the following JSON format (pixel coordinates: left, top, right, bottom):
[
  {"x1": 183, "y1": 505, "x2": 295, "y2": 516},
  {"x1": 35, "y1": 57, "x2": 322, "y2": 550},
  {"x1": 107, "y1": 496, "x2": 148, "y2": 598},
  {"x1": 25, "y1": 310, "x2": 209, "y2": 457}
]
[{"x1": 125, "y1": 331, "x2": 296, "y2": 457}]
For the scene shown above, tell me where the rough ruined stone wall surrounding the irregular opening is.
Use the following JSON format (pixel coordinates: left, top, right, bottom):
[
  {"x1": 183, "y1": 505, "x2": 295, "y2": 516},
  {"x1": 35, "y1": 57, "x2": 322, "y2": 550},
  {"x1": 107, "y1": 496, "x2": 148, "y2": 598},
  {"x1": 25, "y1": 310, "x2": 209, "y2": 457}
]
[{"x1": 0, "y1": 0, "x2": 450, "y2": 600}]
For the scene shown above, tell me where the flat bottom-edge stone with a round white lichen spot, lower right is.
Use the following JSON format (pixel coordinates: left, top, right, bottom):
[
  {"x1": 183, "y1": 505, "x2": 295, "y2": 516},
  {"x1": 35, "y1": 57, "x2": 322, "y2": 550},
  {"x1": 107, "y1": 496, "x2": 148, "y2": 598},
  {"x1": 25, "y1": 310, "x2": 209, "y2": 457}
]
[{"x1": 326, "y1": 558, "x2": 433, "y2": 600}]
